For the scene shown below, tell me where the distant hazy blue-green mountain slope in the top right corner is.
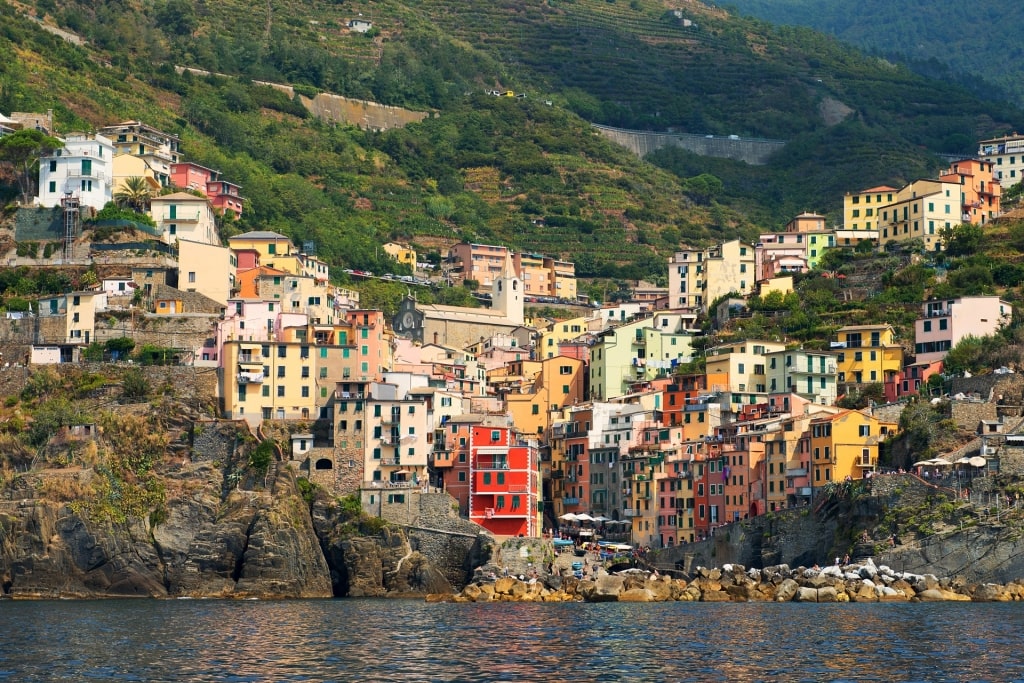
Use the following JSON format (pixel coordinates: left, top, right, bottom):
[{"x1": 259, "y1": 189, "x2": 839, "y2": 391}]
[{"x1": 729, "y1": 0, "x2": 1024, "y2": 104}]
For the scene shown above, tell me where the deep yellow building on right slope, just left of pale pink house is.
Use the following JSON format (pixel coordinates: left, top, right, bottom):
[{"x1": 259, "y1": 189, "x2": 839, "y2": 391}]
[{"x1": 833, "y1": 325, "x2": 903, "y2": 384}]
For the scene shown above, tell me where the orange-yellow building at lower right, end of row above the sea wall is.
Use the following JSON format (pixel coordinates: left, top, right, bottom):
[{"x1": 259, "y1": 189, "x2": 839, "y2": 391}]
[{"x1": 810, "y1": 411, "x2": 898, "y2": 488}]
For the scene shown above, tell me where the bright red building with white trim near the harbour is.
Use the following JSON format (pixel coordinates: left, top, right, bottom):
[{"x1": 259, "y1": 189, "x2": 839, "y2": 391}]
[{"x1": 469, "y1": 425, "x2": 541, "y2": 538}]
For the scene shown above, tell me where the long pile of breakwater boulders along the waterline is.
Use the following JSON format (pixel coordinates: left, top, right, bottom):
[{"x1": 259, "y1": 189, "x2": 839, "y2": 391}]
[{"x1": 427, "y1": 559, "x2": 1024, "y2": 602}]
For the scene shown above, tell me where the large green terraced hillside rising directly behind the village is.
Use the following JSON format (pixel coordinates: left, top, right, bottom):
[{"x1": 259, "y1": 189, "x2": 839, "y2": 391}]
[{"x1": 0, "y1": 0, "x2": 1024, "y2": 278}]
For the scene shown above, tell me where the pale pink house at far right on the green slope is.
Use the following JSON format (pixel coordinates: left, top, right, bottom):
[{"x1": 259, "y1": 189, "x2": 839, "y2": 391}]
[{"x1": 913, "y1": 296, "x2": 1014, "y2": 362}]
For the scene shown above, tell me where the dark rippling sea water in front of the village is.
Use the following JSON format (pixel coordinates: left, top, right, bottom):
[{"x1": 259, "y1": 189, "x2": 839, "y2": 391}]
[{"x1": 0, "y1": 599, "x2": 1024, "y2": 683}]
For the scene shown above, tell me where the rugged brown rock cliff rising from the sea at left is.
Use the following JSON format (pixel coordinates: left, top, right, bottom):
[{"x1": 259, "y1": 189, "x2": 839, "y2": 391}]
[{"x1": 0, "y1": 411, "x2": 466, "y2": 599}]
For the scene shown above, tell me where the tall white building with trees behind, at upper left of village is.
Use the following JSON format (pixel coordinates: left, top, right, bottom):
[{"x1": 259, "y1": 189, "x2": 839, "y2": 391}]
[{"x1": 37, "y1": 133, "x2": 114, "y2": 211}]
